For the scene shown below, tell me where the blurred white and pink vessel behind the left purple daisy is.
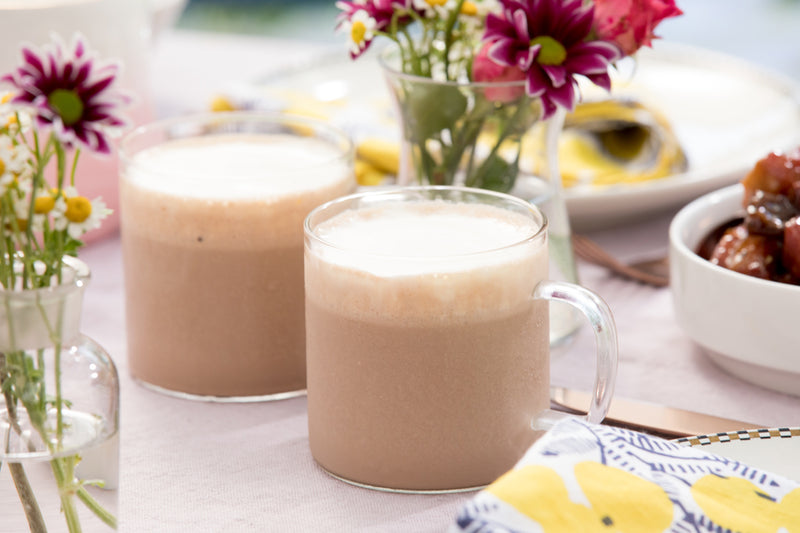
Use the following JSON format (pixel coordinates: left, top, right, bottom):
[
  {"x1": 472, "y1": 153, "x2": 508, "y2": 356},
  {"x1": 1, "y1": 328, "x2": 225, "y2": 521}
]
[{"x1": 0, "y1": 0, "x2": 153, "y2": 241}]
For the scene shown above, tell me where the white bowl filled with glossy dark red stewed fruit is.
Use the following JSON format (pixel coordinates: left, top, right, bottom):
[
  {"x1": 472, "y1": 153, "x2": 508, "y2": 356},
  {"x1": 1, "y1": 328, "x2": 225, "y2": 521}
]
[{"x1": 669, "y1": 145, "x2": 800, "y2": 396}]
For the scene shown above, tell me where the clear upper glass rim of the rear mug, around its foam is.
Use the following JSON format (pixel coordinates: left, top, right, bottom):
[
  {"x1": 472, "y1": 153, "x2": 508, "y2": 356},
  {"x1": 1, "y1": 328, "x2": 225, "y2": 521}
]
[{"x1": 119, "y1": 110, "x2": 355, "y2": 179}]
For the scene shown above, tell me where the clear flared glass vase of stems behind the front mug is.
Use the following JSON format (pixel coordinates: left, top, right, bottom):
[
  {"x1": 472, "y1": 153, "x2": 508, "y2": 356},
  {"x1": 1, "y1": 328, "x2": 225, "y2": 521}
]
[{"x1": 380, "y1": 48, "x2": 582, "y2": 354}]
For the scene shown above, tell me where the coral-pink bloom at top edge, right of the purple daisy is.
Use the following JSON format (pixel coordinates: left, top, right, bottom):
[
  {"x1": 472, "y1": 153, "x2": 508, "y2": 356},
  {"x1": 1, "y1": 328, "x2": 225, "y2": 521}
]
[{"x1": 594, "y1": 0, "x2": 683, "y2": 55}]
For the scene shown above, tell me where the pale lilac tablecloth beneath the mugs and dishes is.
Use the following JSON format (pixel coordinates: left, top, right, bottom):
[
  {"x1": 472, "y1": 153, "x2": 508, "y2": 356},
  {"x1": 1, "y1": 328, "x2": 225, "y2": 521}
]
[{"x1": 82, "y1": 2, "x2": 800, "y2": 532}]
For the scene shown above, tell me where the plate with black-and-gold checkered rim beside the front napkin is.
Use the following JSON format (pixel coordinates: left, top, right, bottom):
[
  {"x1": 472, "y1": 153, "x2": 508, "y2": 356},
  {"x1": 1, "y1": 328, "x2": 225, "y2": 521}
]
[{"x1": 675, "y1": 427, "x2": 800, "y2": 483}]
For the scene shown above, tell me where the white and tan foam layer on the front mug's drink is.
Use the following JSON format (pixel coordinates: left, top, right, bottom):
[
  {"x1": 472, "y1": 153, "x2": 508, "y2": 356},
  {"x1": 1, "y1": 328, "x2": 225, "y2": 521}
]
[{"x1": 305, "y1": 201, "x2": 547, "y2": 325}]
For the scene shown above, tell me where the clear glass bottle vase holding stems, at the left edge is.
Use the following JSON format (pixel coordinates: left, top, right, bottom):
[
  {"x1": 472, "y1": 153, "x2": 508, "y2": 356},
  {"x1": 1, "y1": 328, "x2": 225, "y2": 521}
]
[{"x1": 0, "y1": 257, "x2": 119, "y2": 533}]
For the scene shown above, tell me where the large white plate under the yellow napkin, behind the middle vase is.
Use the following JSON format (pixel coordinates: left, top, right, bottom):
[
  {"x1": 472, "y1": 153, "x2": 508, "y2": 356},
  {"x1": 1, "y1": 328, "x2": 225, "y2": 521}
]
[{"x1": 251, "y1": 41, "x2": 800, "y2": 229}]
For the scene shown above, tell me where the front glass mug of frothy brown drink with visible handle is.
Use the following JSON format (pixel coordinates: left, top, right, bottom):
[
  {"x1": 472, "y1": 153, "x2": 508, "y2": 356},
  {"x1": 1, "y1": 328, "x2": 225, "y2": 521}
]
[{"x1": 305, "y1": 187, "x2": 617, "y2": 492}]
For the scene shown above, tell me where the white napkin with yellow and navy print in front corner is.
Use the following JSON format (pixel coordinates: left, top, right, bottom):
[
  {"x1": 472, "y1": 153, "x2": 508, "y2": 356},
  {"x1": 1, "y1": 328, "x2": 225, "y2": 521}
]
[{"x1": 450, "y1": 419, "x2": 800, "y2": 533}]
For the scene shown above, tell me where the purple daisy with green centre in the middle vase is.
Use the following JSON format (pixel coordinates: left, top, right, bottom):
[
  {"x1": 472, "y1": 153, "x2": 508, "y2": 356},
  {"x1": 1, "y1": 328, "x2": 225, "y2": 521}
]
[{"x1": 483, "y1": 0, "x2": 621, "y2": 119}]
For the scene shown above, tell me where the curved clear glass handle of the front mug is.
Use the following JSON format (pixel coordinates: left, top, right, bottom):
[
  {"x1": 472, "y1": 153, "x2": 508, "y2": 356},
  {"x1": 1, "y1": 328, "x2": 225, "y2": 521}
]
[{"x1": 533, "y1": 281, "x2": 619, "y2": 430}]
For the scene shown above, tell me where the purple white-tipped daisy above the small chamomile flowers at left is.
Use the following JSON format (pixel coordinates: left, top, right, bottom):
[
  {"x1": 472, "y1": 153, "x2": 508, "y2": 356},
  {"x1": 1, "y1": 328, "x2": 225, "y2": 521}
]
[{"x1": 0, "y1": 36, "x2": 130, "y2": 154}]
